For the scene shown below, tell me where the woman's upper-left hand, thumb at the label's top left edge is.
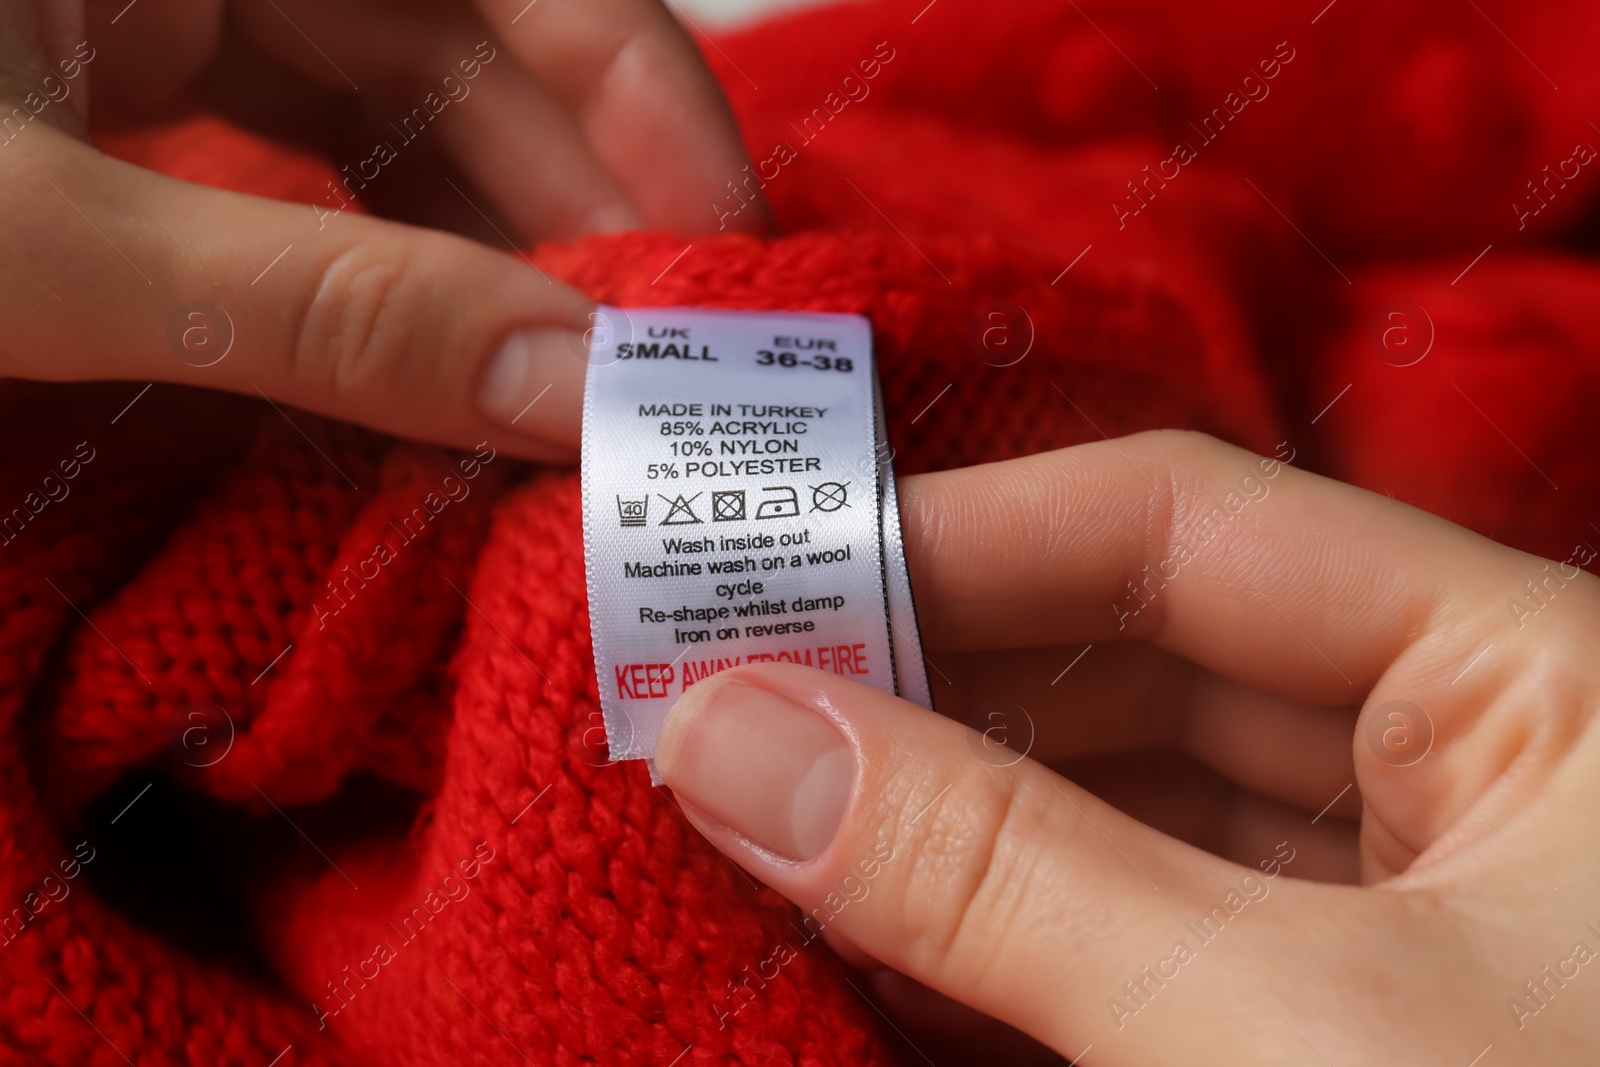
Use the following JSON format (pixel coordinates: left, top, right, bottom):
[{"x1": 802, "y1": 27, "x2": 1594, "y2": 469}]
[{"x1": 0, "y1": 0, "x2": 757, "y2": 458}]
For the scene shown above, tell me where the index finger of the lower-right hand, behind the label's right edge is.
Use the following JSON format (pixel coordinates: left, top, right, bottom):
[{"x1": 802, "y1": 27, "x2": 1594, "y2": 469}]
[{"x1": 901, "y1": 430, "x2": 1576, "y2": 704}]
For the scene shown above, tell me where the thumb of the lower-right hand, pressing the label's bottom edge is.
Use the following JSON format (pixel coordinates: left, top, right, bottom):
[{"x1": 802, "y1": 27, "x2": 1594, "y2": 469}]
[{"x1": 656, "y1": 664, "x2": 1394, "y2": 1064}]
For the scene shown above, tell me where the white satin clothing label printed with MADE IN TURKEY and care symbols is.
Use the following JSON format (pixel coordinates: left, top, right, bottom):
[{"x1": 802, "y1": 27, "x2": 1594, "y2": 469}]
[{"x1": 582, "y1": 306, "x2": 933, "y2": 760}]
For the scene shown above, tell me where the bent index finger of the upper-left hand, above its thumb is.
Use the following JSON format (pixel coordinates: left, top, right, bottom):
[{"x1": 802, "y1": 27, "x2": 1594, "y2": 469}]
[{"x1": 477, "y1": 0, "x2": 766, "y2": 232}]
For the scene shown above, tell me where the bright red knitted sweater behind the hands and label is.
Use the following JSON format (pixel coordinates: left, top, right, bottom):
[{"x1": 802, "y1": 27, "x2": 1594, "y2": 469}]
[{"x1": 0, "y1": 0, "x2": 1600, "y2": 1067}]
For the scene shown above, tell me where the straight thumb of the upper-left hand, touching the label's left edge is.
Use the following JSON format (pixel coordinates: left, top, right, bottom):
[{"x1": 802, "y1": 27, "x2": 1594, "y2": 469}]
[{"x1": 0, "y1": 123, "x2": 586, "y2": 459}]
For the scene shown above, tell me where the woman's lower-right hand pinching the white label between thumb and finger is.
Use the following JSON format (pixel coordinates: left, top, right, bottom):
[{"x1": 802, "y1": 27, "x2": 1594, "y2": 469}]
[{"x1": 656, "y1": 432, "x2": 1600, "y2": 1067}]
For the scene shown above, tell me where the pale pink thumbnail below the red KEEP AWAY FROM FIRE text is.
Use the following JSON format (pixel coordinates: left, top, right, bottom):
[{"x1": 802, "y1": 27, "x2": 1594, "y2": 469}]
[{"x1": 656, "y1": 680, "x2": 856, "y2": 859}]
